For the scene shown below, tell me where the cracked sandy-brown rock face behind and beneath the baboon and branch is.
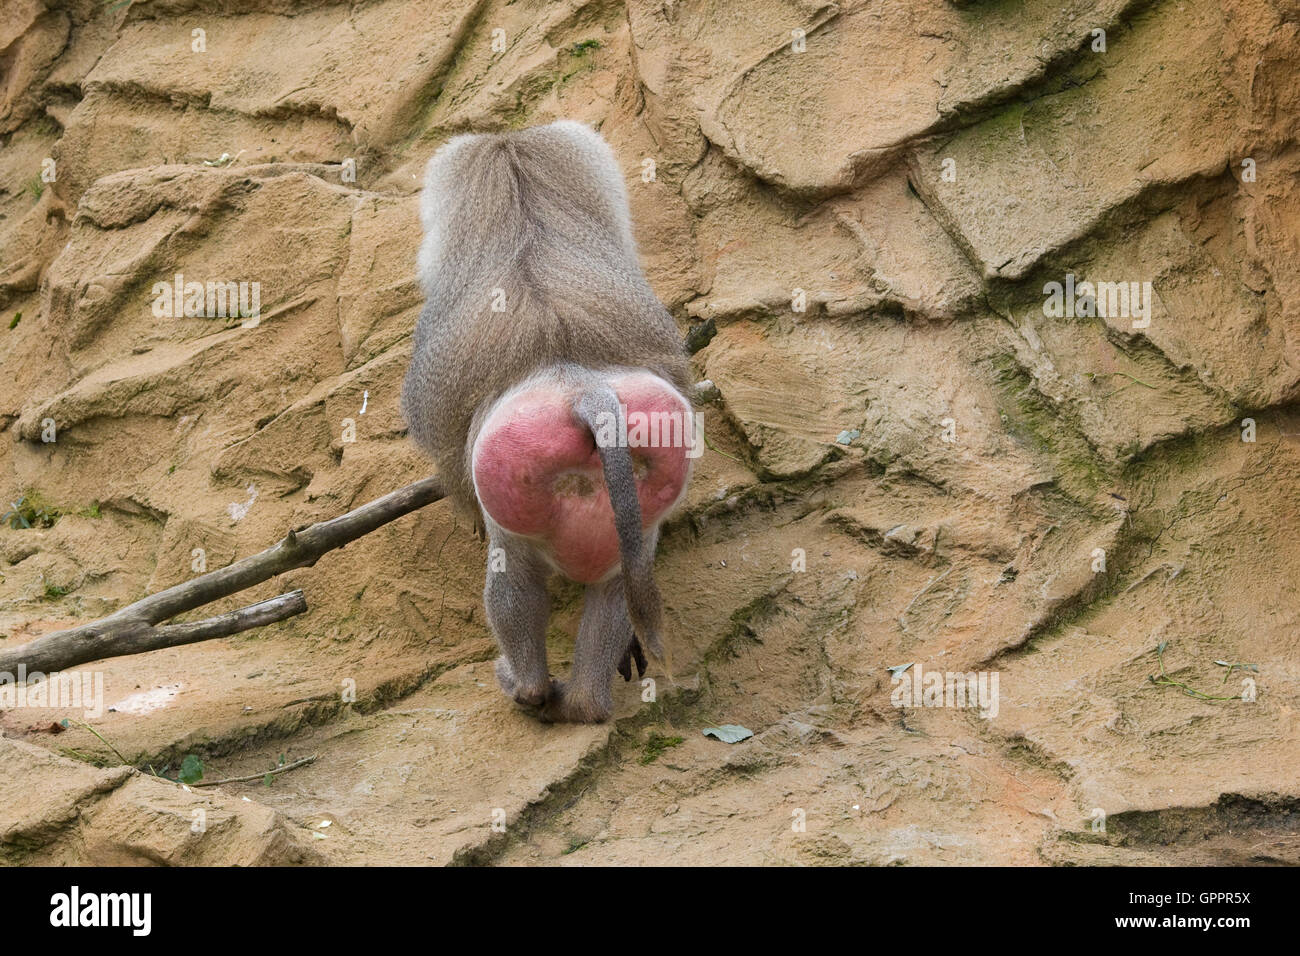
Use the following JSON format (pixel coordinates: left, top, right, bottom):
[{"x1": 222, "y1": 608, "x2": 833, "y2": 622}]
[{"x1": 0, "y1": 0, "x2": 1300, "y2": 865}]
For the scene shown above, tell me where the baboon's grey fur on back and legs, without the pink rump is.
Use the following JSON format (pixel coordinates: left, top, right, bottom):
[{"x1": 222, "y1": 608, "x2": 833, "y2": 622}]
[{"x1": 402, "y1": 121, "x2": 689, "y2": 721}]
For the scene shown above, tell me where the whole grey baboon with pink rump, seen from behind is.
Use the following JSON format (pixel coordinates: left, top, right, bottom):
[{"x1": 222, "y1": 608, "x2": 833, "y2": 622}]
[{"x1": 402, "y1": 121, "x2": 698, "y2": 722}]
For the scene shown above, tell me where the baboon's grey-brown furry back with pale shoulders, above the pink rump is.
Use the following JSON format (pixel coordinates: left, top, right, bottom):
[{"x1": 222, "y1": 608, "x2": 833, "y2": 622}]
[{"x1": 402, "y1": 122, "x2": 688, "y2": 506}]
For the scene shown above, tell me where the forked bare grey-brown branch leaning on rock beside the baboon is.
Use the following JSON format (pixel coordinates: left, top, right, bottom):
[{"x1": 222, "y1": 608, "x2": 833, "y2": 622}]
[{"x1": 0, "y1": 477, "x2": 445, "y2": 678}]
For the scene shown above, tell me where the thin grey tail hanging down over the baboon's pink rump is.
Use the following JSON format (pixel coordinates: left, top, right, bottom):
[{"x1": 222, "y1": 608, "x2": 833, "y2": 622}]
[{"x1": 573, "y1": 384, "x2": 668, "y2": 670}]
